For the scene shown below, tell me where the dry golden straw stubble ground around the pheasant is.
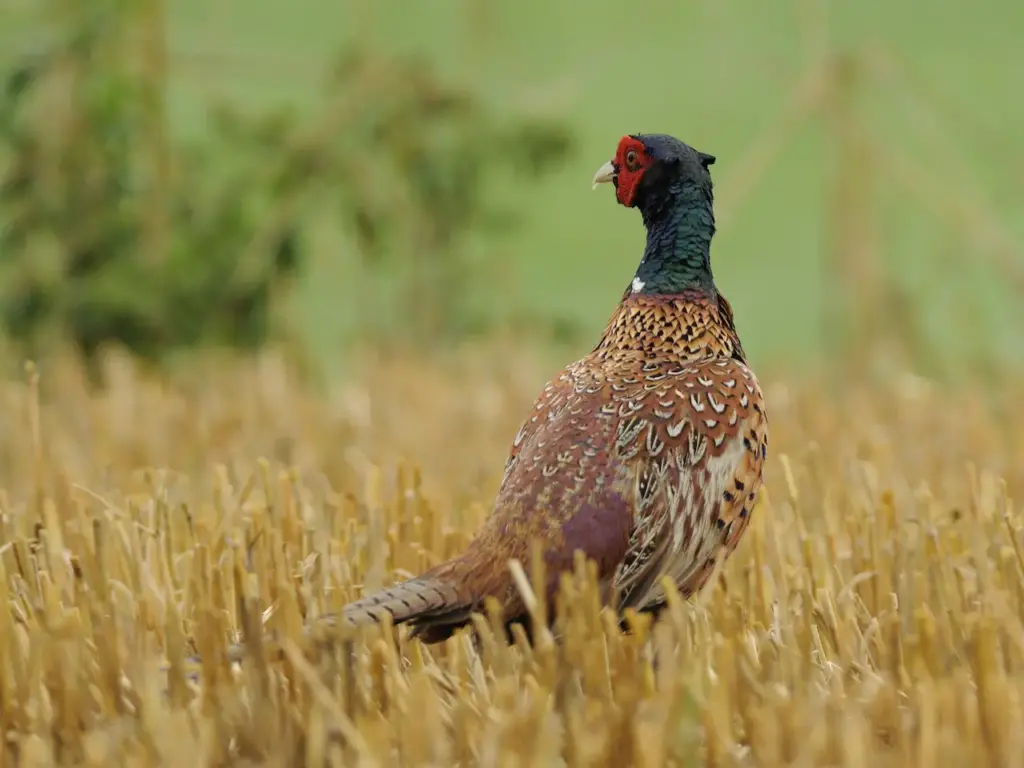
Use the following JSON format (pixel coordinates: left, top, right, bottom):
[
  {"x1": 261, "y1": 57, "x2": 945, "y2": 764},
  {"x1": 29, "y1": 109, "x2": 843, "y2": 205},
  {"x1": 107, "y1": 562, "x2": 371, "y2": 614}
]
[{"x1": 0, "y1": 350, "x2": 1024, "y2": 768}]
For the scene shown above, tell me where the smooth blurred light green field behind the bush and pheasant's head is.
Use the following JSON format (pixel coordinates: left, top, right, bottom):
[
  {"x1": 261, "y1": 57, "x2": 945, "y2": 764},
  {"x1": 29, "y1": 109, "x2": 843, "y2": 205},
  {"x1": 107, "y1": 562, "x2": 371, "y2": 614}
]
[{"x1": 0, "y1": 0, "x2": 1024, "y2": 370}]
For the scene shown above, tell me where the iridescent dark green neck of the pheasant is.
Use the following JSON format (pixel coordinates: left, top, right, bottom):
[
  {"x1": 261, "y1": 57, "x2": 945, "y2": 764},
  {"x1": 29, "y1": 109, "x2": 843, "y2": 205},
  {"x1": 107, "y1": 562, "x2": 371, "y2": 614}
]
[{"x1": 633, "y1": 182, "x2": 716, "y2": 294}]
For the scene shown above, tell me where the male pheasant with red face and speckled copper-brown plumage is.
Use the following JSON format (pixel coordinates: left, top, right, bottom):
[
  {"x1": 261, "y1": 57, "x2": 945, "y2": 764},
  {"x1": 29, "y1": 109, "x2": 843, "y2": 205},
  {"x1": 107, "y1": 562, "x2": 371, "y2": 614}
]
[{"x1": 333, "y1": 134, "x2": 768, "y2": 643}]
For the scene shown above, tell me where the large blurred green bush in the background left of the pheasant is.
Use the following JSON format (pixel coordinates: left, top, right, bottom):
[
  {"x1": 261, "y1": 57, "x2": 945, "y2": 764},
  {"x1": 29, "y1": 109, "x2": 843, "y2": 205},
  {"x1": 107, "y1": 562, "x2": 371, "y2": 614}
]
[{"x1": 0, "y1": 0, "x2": 570, "y2": 382}]
